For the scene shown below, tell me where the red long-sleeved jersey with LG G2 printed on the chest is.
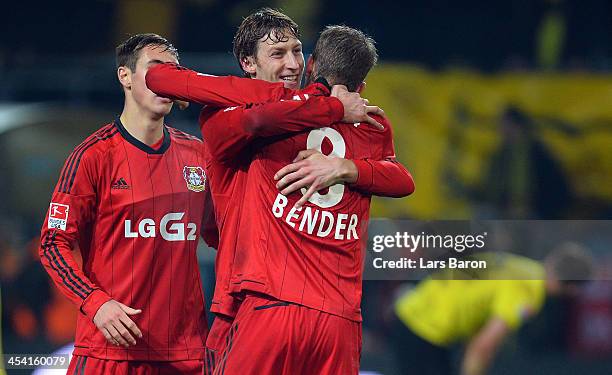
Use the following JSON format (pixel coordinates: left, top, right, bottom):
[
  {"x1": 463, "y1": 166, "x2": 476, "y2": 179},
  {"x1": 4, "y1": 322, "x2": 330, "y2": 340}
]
[{"x1": 40, "y1": 120, "x2": 215, "y2": 361}]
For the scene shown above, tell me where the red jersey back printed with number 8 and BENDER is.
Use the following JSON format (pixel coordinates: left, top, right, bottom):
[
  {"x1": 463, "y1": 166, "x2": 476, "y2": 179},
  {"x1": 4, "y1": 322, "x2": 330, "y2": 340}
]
[{"x1": 232, "y1": 103, "x2": 395, "y2": 321}]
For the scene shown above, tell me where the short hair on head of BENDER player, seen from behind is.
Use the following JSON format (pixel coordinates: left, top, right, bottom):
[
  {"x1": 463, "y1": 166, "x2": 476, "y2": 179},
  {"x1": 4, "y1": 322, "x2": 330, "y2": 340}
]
[{"x1": 312, "y1": 25, "x2": 378, "y2": 91}]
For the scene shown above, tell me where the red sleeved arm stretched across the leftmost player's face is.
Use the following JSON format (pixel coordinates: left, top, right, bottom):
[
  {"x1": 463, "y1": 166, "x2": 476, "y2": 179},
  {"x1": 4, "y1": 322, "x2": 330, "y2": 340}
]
[{"x1": 145, "y1": 63, "x2": 294, "y2": 107}]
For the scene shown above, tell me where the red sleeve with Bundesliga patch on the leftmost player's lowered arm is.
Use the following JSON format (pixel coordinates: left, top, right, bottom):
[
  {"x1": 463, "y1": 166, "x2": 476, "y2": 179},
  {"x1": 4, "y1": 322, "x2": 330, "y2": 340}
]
[{"x1": 39, "y1": 150, "x2": 111, "y2": 319}]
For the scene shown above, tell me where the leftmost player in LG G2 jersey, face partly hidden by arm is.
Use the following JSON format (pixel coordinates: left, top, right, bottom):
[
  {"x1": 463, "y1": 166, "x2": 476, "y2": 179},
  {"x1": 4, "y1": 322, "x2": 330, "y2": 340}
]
[{"x1": 40, "y1": 34, "x2": 217, "y2": 374}]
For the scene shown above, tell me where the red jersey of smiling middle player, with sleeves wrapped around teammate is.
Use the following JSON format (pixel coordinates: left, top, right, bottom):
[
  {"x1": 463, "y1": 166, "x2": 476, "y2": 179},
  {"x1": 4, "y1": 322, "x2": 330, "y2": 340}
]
[{"x1": 146, "y1": 64, "x2": 414, "y2": 316}]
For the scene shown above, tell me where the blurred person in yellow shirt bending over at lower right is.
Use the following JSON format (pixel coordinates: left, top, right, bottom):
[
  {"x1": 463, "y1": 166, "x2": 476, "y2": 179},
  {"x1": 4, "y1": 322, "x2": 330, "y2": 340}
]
[{"x1": 392, "y1": 244, "x2": 593, "y2": 375}]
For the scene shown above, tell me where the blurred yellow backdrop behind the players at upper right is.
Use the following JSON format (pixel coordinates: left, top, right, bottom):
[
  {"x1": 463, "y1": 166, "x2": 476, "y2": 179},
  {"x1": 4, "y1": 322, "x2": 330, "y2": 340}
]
[{"x1": 364, "y1": 64, "x2": 612, "y2": 219}]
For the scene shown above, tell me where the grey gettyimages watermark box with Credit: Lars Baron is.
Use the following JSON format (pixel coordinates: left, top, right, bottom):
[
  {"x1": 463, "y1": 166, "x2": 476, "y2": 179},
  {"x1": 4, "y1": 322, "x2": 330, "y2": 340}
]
[{"x1": 364, "y1": 219, "x2": 612, "y2": 281}]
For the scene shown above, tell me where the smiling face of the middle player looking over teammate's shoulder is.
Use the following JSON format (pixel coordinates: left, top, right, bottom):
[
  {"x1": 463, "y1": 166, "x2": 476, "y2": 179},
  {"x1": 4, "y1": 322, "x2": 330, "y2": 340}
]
[{"x1": 242, "y1": 31, "x2": 304, "y2": 89}]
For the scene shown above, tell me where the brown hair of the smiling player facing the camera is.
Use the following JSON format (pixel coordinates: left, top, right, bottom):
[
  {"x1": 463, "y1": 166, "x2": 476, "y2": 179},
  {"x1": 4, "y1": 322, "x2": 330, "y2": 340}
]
[{"x1": 234, "y1": 8, "x2": 300, "y2": 77}]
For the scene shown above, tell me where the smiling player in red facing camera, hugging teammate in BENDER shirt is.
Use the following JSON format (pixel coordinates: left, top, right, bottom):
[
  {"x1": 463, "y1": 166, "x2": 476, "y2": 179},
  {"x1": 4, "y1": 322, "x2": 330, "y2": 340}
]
[{"x1": 147, "y1": 9, "x2": 413, "y2": 375}]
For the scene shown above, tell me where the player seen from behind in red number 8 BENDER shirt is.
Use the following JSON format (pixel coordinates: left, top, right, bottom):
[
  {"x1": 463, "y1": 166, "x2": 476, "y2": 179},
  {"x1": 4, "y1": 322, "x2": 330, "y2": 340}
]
[{"x1": 209, "y1": 26, "x2": 413, "y2": 374}]
